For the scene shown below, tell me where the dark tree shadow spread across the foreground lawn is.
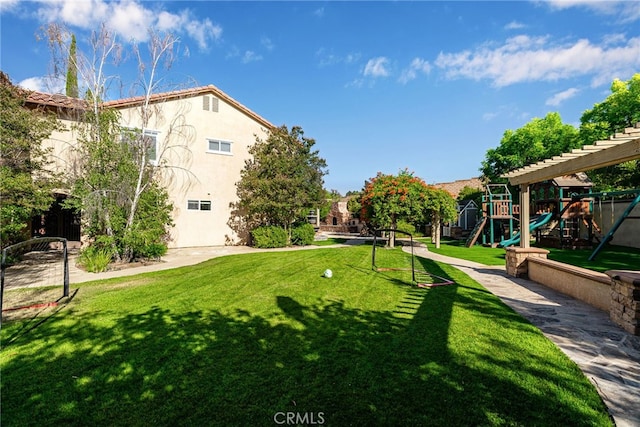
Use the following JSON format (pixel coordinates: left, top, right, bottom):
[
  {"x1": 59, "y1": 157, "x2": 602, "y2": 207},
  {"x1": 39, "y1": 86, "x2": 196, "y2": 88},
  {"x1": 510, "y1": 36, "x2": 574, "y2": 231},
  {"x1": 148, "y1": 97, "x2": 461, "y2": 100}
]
[{"x1": 1, "y1": 274, "x2": 608, "y2": 426}]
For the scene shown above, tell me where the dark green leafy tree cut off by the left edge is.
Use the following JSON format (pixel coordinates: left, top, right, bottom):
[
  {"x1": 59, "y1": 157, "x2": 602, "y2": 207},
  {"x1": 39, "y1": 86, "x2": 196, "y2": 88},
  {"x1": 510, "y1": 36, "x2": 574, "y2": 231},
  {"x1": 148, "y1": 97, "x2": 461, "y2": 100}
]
[{"x1": 0, "y1": 72, "x2": 59, "y2": 247}]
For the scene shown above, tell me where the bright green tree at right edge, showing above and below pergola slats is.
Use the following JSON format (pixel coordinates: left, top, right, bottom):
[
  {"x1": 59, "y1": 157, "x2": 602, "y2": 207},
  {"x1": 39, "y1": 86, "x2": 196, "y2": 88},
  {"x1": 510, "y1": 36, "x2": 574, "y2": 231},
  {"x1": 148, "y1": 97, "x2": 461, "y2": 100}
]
[{"x1": 580, "y1": 74, "x2": 640, "y2": 190}]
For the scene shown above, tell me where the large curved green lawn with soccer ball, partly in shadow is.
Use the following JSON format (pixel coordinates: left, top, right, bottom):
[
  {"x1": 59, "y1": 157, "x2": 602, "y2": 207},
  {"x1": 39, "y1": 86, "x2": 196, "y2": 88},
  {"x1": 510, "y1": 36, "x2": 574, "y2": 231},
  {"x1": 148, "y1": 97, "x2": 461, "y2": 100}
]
[{"x1": 0, "y1": 246, "x2": 612, "y2": 426}]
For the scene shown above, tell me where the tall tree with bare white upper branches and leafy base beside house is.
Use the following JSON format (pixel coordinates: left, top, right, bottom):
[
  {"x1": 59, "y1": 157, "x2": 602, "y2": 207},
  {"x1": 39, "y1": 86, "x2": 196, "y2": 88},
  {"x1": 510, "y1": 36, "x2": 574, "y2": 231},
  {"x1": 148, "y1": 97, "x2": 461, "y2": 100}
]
[{"x1": 46, "y1": 25, "x2": 189, "y2": 261}]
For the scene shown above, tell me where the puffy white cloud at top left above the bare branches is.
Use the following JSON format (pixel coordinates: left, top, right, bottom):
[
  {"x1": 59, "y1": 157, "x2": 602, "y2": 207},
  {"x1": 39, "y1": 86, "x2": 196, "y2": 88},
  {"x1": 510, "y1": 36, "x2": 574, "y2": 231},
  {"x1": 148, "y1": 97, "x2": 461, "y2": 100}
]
[{"x1": 32, "y1": 0, "x2": 222, "y2": 49}]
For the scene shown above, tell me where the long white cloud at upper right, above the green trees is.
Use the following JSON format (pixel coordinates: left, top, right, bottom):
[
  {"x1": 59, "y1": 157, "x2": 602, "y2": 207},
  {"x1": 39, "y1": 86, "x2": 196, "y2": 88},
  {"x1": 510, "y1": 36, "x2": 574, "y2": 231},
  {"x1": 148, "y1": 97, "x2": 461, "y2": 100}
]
[{"x1": 435, "y1": 35, "x2": 640, "y2": 87}]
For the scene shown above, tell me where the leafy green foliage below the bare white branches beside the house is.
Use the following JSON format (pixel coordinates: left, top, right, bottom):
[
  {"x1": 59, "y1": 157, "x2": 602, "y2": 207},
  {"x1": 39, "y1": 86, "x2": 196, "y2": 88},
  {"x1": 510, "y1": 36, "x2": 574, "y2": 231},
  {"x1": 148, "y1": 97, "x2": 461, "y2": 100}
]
[{"x1": 67, "y1": 108, "x2": 173, "y2": 262}]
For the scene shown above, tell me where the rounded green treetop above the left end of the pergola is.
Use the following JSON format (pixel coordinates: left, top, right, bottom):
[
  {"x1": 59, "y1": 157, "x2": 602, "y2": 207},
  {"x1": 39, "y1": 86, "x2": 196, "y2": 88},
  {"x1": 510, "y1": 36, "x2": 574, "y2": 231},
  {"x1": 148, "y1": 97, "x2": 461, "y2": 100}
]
[{"x1": 481, "y1": 113, "x2": 582, "y2": 182}]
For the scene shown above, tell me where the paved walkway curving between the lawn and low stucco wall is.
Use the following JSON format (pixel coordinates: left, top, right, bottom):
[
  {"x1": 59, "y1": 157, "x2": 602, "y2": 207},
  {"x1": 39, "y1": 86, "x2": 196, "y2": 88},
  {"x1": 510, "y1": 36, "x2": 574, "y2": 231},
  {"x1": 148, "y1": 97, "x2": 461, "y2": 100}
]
[{"x1": 403, "y1": 247, "x2": 640, "y2": 427}]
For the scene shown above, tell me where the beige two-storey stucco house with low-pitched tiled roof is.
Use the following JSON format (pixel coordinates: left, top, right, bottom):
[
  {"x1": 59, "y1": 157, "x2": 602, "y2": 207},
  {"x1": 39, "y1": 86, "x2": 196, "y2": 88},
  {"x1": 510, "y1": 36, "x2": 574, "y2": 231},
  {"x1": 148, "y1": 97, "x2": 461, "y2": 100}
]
[{"x1": 27, "y1": 85, "x2": 274, "y2": 248}]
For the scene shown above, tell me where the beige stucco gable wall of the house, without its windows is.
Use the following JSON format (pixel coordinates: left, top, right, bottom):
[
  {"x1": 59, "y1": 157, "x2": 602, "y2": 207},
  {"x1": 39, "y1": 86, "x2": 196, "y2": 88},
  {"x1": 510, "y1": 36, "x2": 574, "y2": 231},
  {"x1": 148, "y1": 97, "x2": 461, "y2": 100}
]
[{"x1": 116, "y1": 95, "x2": 267, "y2": 247}]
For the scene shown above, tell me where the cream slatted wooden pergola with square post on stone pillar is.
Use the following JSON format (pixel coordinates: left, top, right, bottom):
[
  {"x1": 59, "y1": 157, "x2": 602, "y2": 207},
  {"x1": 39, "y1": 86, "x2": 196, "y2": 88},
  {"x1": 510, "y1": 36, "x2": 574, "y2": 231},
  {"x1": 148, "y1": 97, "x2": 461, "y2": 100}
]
[{"x1": 502, "y1": 123, "x2": 640, "y2": 248}]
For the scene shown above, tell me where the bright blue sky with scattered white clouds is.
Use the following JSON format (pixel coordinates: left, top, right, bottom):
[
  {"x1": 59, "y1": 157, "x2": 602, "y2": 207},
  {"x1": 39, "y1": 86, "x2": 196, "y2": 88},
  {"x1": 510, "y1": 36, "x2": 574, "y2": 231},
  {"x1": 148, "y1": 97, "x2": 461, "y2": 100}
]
[{"x1": 0, "y1": 0, "x2": 640, "y2": 194}]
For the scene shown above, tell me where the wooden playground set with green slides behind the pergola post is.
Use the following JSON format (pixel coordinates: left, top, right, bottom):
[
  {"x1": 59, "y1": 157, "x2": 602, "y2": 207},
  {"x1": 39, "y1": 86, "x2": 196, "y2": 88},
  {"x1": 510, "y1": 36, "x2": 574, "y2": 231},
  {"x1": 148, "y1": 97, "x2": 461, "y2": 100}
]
[{"x1": 466, "y1": 173, "x2": 640, "y2": 260}]
